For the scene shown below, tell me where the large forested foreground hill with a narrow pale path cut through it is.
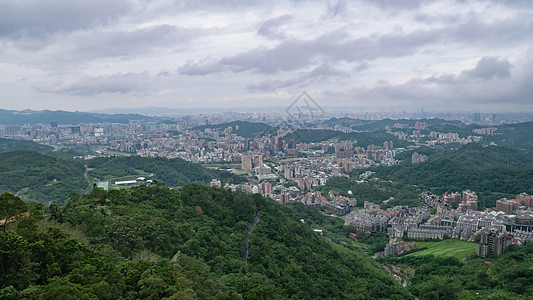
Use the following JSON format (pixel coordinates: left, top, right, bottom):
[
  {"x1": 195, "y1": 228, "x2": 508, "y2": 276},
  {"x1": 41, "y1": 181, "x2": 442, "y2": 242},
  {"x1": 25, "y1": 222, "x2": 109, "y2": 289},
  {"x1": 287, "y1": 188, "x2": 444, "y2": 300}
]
[{"x1": 0, "y1": 185, "x2": 413, "y2": 299}]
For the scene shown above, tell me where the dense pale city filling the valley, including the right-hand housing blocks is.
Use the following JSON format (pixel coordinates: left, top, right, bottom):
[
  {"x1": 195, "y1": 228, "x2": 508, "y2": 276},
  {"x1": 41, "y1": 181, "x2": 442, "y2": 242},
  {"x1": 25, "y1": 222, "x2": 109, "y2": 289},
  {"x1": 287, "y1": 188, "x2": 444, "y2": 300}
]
[{"x1": 0, "y1": 109, "x2": 533, "y2": 257}]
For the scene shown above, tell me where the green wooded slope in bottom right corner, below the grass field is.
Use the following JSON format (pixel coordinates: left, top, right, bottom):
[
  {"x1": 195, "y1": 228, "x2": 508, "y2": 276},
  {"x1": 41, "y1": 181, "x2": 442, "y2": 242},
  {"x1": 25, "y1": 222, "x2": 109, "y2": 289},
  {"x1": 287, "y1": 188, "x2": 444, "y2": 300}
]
[{"x1": 380, "y1": 241, "x2": 533, "y2": 299}]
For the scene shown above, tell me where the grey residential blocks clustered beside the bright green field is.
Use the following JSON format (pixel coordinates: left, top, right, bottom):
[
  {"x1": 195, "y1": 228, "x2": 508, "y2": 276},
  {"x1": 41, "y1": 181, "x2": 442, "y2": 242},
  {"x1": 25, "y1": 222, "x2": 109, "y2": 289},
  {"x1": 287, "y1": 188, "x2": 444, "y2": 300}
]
[{"x1": 344, "y1": 190, "x2": 533, "y2": 257}]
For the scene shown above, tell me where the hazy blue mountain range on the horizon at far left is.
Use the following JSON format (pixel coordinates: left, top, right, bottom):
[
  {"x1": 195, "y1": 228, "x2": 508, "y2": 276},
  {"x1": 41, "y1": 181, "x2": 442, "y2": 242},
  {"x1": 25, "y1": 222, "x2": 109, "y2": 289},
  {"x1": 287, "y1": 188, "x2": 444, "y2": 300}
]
[{"x1": 0, "y1": 109, "x2": 150, "y2": 125}]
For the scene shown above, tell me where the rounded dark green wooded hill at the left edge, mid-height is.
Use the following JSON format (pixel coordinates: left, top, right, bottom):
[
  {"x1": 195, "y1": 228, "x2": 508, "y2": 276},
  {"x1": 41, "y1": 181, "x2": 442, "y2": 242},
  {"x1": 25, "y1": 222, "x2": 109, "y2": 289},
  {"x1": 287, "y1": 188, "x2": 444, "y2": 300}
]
[{"x1": 0, "y1": 151, "x2": 88, "y2": 202}]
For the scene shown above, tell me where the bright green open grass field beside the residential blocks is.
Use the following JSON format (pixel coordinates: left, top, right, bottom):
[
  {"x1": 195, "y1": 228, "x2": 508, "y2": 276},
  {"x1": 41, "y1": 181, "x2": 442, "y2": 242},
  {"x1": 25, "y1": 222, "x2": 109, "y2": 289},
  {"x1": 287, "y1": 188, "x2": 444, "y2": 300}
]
[{"x1": 407, "y1": 239, "x2": 476, "y2": 260}]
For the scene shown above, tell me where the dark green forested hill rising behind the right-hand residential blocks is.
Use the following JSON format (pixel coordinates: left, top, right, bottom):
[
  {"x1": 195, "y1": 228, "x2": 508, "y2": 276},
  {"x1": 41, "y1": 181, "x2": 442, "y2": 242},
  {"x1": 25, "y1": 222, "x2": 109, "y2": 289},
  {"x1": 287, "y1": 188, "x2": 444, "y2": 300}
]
[{"x1": 376, "y1": 143, "x2": 533, "y2": 207}]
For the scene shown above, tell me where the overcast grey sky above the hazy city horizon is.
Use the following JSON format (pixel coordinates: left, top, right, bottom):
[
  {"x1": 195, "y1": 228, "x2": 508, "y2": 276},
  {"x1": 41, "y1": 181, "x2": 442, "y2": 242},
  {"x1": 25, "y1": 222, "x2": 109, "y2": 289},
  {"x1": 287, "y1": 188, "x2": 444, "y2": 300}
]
[{"x1": 0, "y1": 0, "x2": 533, "y2": 111}]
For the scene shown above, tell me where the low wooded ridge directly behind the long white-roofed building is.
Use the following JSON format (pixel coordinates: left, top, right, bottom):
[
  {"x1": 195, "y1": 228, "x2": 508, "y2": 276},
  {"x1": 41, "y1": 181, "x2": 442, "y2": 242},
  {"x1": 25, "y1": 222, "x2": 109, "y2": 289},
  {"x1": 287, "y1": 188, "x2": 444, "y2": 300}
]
[{"x1": 85, "y1": 156, "x2": 245, "y2": 187}]
